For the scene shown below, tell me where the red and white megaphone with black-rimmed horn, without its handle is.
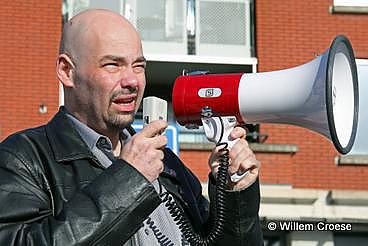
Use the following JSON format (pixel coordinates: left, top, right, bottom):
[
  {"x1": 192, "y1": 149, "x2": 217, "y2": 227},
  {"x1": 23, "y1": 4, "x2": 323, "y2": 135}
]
[{"x1": 172, "y1": 35, "x2": 359, "y2": 154}]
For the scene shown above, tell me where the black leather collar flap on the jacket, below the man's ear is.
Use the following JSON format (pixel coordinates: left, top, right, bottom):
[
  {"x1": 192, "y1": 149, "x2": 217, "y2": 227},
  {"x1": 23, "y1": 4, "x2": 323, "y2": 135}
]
[{"x1": 46, "y1": 107, "x2": 94, "y2": 162}]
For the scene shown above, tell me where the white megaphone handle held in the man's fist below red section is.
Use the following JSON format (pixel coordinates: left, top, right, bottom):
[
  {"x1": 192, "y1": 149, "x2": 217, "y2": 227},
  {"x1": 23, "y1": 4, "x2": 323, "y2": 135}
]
[{"x1": 201, "y1": 116, "x2": 248, "y2": 183}]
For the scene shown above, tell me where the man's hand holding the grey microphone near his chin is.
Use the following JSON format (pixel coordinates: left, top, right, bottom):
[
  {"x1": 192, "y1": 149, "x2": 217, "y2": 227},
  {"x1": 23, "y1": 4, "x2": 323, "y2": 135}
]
[{"x1": 119, "y1": 120, "x2": 167, "y2": 182}]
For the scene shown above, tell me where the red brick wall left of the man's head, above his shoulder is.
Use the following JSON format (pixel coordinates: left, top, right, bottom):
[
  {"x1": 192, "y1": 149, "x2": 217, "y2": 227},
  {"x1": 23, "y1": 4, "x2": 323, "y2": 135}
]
[{"x1": 0, "y1": 0, "x2": 61, "y2": 140}]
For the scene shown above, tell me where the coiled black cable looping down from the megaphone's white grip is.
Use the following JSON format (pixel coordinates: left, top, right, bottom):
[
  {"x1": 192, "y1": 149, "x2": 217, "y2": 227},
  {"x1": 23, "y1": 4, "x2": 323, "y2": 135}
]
[{"x1": 160, "y1": 117, "x2": 229, "y2": 246}]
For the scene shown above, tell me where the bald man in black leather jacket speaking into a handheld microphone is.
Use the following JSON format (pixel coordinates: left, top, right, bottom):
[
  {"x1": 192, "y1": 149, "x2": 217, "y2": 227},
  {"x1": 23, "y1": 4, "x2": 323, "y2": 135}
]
[{"x1": 0, "y1": 10, "x2": 262, "y2": 245}]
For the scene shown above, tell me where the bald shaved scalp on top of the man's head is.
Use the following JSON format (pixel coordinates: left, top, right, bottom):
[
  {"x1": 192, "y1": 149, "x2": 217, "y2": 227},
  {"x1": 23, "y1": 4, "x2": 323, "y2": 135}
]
[{"x1": 59, "y1": 9, "x2": 140, "y2": 64}]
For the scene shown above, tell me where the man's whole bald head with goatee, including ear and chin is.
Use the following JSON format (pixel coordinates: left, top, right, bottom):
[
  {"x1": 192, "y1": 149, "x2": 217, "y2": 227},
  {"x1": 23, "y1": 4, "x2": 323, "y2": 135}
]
[{"x1": 56, "y1": 10, "x2": 146, "y2": 139}]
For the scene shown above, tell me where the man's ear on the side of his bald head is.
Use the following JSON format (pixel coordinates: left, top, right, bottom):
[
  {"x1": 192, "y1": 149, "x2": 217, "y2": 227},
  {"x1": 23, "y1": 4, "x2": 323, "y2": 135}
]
[{"x1": 56, "y1": 54, "x2": 75, "y2": 87}]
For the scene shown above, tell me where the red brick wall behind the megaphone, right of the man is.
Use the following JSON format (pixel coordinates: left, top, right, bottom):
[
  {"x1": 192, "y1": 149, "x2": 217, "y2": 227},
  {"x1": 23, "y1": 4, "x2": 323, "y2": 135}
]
[{"x1": 181, "y1": 0, "x2": 368, "y2": 190}]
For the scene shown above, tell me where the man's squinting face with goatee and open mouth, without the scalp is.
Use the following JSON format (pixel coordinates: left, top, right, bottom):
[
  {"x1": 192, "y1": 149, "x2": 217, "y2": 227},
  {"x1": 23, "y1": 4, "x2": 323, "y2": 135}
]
[{"x1": 74, "y1": 24, "x2": 146, "y2": 131}]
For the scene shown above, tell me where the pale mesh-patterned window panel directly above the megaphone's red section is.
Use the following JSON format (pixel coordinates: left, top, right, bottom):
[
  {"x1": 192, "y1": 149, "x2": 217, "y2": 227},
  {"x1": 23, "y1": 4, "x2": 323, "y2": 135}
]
[{"x1": 196, "y1": 0, "x2": 253, "y2": 57}]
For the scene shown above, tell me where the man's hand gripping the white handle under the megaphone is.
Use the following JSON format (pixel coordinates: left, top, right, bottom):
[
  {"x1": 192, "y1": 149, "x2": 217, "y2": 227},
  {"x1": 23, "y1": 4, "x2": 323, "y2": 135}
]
[{"x1": 208, "y1": 127, "x2": 260, "y2": 190}]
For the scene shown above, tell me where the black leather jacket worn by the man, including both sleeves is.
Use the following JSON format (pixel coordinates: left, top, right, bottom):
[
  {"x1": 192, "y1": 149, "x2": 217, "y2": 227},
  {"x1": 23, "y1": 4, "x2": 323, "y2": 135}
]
[{"x1": 0, "y1": 110, "x2": 263, "y2": 246}]
